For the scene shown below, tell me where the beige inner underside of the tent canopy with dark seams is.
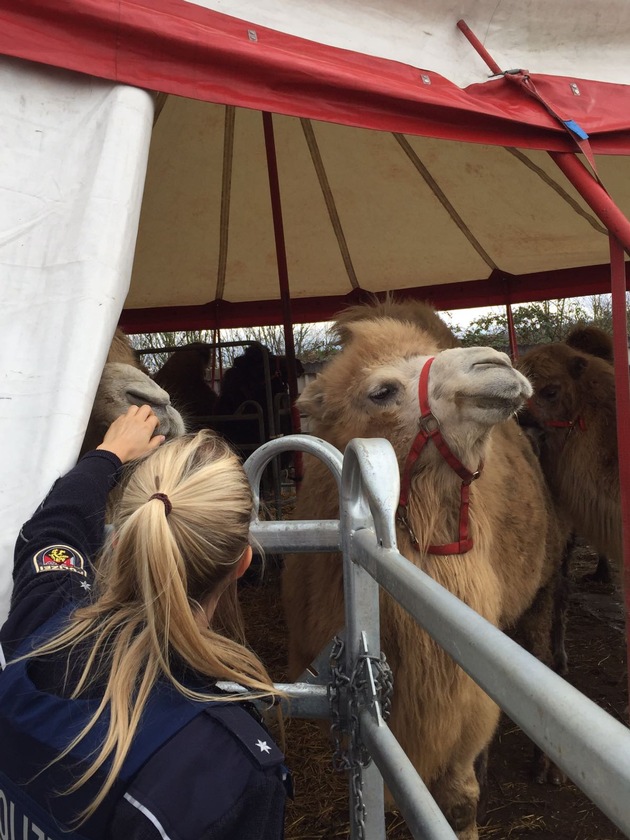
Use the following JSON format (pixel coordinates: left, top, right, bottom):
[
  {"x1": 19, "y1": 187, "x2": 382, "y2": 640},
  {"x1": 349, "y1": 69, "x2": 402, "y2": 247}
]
[{"x1": 123, "y1": 98, "x2": 630, "y2": 331}]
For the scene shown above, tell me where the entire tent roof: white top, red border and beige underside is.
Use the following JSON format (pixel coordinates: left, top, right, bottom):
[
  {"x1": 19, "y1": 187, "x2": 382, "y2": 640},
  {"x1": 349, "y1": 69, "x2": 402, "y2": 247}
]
[{"x1": 0, "y1": 0, "x2": 630, "y2": 331}]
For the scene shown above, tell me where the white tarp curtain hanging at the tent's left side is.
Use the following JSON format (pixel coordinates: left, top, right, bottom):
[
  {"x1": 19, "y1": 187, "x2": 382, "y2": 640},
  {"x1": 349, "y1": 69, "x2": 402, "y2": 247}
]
[{"x1": 0, "y1": 58, "x2": 154, "y2": 621}]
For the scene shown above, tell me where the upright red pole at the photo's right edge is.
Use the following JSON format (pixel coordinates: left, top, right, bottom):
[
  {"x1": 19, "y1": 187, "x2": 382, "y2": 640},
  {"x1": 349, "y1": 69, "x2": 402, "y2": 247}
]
[{"x1": 609, "y1": 235, "x2": 630, "y2": 696}]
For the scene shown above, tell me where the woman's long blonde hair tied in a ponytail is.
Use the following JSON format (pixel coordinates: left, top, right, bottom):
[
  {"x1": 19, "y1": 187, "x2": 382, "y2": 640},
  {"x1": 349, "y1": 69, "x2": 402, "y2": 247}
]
[{"x1": 31, "y1": 430, "x2": 276, "y2": 820}]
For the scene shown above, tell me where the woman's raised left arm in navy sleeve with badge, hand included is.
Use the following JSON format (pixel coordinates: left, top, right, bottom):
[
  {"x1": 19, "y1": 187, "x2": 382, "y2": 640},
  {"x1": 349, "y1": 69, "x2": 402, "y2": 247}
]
[{"x1": 0, "y1": 406, "x2": 164, "y2": 659}]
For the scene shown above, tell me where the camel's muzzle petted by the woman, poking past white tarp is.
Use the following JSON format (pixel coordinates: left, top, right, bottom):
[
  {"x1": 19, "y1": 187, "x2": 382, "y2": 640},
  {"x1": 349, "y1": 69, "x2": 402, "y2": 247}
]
[{"x1": 81, "y1": 362, "x2": 186, "y2": 452}]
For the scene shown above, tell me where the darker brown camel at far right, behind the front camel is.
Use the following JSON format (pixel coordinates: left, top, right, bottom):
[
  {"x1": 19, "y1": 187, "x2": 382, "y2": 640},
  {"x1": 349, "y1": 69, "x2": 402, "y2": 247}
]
[{"x1": 519, "y1": 327, "x2": 623, "y2": 584}]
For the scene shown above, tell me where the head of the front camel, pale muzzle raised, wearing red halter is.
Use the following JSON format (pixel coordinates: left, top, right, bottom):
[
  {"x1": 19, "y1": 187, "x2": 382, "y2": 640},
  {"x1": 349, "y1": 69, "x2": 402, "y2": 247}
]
[{"x1": 298, "y1": 317, "x2": 532, "y2": 467}]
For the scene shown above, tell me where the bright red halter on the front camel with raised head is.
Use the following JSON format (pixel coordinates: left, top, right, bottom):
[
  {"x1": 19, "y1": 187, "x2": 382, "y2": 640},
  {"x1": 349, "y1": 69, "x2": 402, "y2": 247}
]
[{"x1": 397, "y1": 357, "x2": 483, "y2": 554}]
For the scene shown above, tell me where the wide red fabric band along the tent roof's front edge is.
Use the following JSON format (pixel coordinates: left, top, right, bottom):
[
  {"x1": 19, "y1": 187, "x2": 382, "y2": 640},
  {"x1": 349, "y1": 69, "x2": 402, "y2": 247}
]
[{"x1": 0, "y1": 0, "x2": 630, "y2": 154}]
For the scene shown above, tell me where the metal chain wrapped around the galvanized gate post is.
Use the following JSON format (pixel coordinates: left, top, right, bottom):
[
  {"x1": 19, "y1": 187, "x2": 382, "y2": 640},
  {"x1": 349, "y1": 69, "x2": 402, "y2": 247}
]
[{"x1": 328, "y1": 633, "x2": 393, "y2": 840}]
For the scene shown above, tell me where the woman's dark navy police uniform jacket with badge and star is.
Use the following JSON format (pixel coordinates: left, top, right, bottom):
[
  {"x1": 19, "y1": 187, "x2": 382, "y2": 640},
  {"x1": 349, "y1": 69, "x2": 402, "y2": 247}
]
[{"x1": 0, "y1": 450, "x2": 288, "y2": 840}]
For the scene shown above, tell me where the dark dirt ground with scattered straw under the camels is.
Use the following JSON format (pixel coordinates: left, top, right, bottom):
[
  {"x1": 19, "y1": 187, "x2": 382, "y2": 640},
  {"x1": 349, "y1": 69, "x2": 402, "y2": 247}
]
[{"x1": 241, "y1": 546, "x2": 628, "y2": 840}]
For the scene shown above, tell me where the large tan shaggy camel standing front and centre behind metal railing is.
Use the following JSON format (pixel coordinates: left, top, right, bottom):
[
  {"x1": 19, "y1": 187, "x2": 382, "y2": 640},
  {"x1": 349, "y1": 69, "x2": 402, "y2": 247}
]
[{"x1": 283, "y1": 301, "x2": 562, "y2": 840}]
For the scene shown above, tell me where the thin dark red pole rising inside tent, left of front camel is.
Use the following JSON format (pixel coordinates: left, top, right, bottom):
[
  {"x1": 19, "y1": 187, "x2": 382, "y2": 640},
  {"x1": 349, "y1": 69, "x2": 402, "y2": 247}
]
[{"x1": 262, "y1": 111, "x2": 302, "y2": 485}]
